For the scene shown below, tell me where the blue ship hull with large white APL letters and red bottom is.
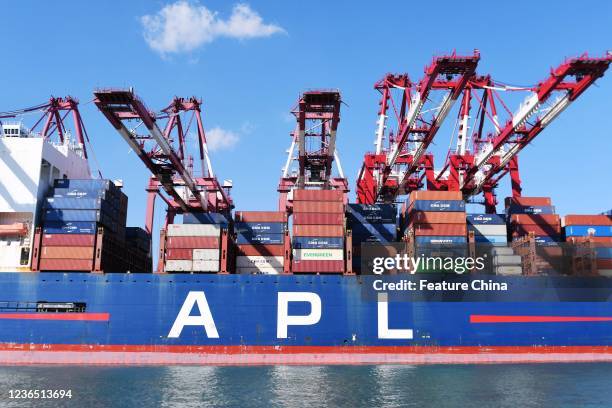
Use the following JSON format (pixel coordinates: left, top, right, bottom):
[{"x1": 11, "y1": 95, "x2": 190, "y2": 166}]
[{"x1": 0, "y1": 273, "x2": 612, "y2": 364}]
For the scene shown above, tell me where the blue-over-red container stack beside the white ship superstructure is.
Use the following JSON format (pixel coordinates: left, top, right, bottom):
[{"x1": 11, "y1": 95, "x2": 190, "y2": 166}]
[{"x1": 38, "y1": 179, "x2": 151, "y2": 272}]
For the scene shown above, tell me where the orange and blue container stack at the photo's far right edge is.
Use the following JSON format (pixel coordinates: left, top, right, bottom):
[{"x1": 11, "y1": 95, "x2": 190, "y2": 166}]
[{"x1": 564, "y1": 214, "x2": 612, "y2": 276}]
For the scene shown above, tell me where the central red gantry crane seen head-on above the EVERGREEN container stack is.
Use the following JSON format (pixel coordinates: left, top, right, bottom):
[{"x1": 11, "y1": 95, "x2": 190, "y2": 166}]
[{"x1": 278, "y1": 90, "x2": 349, "y2": 211}]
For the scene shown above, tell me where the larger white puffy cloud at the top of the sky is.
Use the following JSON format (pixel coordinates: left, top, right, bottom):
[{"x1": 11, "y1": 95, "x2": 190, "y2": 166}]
[{"x1": 140, "y1": 0, "x2": 285, "y2": 55}]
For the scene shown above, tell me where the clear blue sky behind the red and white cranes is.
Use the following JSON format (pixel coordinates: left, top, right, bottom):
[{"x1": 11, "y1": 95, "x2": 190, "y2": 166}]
[{"x1": 0, "y1": 1, "x2": 612, "y2": 237}]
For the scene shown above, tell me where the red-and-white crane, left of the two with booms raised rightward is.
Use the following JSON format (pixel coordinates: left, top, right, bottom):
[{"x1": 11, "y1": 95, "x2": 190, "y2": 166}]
[{"x1": 357, "y1": 50, "x2": 480, "y2": 204}]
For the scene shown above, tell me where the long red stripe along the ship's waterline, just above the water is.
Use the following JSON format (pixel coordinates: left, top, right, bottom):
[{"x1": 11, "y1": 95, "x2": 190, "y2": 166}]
[{"x1": 0, "y1": 343, "x2": 612, "y2": 365}]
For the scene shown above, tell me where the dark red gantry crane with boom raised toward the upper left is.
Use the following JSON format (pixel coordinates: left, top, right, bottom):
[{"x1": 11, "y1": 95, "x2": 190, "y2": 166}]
[{"x1": 94, "y1": 89, "x2": 233, "y2": 233}]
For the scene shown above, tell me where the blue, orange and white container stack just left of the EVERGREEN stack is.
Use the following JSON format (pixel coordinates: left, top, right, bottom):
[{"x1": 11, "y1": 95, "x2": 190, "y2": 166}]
[{"x1": 236, "y1": 211, "x2": 288, "y2": 275}]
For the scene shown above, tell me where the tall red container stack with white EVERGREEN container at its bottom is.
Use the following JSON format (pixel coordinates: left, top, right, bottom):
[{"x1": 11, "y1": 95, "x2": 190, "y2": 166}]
[{"x1": 291, "y1": 190, "x2": 345, "y2": 273}]
